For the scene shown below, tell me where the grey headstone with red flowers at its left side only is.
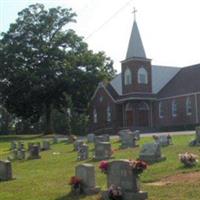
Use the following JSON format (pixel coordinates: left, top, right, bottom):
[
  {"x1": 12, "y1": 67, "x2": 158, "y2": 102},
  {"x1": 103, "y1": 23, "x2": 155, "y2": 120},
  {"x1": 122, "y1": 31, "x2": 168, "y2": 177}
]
[{"x1": 75, "y1": 163, "x2": 100, "y2": 194}]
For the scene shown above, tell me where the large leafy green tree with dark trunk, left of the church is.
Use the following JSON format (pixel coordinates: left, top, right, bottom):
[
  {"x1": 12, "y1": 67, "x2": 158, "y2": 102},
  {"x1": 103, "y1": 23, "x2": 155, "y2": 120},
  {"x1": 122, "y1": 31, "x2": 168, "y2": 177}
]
[{"x1": 0, "y1": 4, "x2": 115, "y2": 133}]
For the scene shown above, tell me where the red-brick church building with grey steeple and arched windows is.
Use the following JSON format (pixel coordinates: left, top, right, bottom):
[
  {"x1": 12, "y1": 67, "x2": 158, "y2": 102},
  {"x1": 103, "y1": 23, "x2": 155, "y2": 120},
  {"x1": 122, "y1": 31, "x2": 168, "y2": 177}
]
[{"x1": 89, "y1": 20, "x2": 200, "y2": 134}]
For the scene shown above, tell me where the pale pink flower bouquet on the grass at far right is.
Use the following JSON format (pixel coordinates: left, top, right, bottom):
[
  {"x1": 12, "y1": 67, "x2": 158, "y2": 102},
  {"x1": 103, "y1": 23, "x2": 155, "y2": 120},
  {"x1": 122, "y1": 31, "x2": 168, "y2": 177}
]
[{"x1": 179, "y1": 152, "x2": 198, "y2": 167}]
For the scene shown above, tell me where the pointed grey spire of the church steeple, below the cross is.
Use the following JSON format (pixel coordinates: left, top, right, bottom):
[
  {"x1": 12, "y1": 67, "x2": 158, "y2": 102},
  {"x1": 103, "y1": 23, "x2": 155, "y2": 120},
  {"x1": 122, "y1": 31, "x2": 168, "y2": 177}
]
[{"x1": 126, "y1": 20, "x2": 146, "y2": 59}]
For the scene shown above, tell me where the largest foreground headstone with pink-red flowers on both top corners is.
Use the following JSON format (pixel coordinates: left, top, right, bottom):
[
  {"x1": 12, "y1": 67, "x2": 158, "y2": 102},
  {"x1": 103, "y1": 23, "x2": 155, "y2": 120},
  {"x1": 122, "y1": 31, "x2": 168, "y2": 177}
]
[{"x1": 102, "y1": 160, "x2": 148, "y2": 200}]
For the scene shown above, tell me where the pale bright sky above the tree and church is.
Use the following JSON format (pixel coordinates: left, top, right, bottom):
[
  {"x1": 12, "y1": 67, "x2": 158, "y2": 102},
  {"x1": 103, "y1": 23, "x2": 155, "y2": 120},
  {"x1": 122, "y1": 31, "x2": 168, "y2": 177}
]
[{"x1": 0, "y1": 0, "x2": 200, "y2": 72}]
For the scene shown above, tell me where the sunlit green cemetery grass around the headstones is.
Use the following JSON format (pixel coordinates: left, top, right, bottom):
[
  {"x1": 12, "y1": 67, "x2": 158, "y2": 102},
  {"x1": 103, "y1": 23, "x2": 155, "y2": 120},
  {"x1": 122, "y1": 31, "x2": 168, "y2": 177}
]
[{"x1": 0, "y1": 135, "x2": 200, "y2": 200}]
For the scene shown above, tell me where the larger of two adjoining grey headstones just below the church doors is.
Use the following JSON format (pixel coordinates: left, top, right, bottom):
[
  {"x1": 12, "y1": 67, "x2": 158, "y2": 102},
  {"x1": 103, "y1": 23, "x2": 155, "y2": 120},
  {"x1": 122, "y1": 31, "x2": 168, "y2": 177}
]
[{"x1": 121, "y1": 132, "x2": 138, "y2": 149}]
